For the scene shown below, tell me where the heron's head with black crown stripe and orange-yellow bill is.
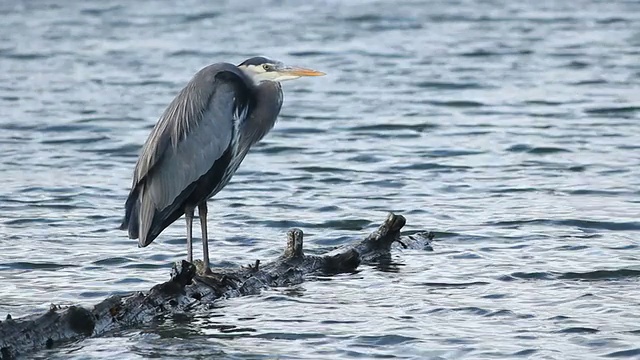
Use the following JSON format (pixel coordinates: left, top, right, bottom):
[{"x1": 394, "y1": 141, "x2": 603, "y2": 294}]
[{"x1": 238, "y1": 56, "x2": 324, "y2": 83}]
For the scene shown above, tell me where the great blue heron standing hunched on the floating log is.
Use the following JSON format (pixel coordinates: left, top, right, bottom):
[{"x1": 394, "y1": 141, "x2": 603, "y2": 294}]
[{"x1": 120, "y1": 57, "x2": 324, "y2": 270}]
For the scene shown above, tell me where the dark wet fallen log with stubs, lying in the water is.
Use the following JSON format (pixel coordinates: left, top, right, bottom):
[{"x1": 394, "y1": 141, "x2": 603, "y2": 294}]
[{"x1": 0, "y1": 214, "x2": 432, "y2": 360}]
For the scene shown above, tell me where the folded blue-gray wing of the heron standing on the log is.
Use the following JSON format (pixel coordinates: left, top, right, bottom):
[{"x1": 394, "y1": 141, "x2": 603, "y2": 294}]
[{"x1": 123, "y1": 64, "x2": 251, "y2": 246}]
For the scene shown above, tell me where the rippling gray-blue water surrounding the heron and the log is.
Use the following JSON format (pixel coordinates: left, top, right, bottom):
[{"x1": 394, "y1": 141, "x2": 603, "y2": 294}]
[{"x1": 0, "y1": 0, "x2": 640, "y2": 359}]
